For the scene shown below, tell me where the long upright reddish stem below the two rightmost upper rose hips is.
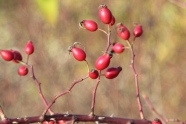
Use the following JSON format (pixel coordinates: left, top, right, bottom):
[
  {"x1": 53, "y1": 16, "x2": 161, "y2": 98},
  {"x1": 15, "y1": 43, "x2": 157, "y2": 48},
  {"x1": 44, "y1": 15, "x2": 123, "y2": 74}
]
[{"x1": 126, "y1": 40, "x2": 144, "y2": 119}]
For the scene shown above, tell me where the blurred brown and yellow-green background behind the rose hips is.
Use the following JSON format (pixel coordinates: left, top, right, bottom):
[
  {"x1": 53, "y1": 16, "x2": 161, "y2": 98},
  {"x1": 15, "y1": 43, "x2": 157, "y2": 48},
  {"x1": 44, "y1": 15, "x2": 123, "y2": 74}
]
[{"x1": 0, "y1": 0, "x2": 186, "y2": 120}]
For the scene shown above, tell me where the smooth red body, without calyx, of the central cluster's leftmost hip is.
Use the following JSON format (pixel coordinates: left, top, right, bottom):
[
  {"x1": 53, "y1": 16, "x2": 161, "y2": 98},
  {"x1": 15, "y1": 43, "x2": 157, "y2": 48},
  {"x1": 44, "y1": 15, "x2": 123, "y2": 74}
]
[{"x1": 71, "y1": 47, "x2": 86, "y2": 61}]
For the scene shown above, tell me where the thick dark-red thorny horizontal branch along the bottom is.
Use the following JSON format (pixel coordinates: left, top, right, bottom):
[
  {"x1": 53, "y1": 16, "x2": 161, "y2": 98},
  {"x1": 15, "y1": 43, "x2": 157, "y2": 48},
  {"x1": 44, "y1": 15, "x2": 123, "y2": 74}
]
[{"x1": 0, "y1": 114, "x2": 151, "y2": 124}]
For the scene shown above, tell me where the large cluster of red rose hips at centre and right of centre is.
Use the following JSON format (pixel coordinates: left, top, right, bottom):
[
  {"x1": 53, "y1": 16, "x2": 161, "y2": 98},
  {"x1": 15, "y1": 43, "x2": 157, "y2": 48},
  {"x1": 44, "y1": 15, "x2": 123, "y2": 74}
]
[{"x1": 69, "y1": 4, "x2": 143, "y2": 79}]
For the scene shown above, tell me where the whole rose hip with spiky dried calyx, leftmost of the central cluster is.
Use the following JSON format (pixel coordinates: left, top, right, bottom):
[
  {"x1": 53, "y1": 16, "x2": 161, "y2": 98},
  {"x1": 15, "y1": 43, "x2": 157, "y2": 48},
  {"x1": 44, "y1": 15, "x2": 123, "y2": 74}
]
[{"x1": 68, "y1": 42, "x2": 86, "y2": 61}]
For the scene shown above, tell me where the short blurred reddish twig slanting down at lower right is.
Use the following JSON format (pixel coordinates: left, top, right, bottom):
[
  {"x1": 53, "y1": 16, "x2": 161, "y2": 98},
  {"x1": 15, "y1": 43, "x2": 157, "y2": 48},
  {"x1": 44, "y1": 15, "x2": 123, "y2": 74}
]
[{"x1": 143, "y1": 95, "x2": 167, "y2": 124}]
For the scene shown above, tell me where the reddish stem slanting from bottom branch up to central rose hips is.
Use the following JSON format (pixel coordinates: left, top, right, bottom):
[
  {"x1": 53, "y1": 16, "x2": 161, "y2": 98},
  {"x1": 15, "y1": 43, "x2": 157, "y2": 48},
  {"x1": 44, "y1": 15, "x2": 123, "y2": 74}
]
[{"x1": 42, "y1": 76, "x2": 89, "y2": 116}]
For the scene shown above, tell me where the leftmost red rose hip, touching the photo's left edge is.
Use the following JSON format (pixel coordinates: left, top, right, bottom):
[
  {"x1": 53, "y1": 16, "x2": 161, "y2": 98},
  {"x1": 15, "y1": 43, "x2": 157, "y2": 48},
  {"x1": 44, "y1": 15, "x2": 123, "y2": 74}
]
[{"x1": 1, "y1": 50, "x2": 14, "y2": 61}]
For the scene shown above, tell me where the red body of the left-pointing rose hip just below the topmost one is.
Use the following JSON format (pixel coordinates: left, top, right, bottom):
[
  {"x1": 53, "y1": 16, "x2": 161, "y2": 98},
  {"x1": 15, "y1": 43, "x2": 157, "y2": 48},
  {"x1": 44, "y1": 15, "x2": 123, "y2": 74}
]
[{"x1": 83, "y1": 20, "x2": 98, "y2": 32}]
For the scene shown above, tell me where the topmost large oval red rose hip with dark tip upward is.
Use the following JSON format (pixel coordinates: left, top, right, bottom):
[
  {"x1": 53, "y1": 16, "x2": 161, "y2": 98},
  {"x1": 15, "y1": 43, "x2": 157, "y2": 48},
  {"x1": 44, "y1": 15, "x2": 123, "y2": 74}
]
[{"x1": 98, "y1": 5, "x2": 112, "y2": 24}]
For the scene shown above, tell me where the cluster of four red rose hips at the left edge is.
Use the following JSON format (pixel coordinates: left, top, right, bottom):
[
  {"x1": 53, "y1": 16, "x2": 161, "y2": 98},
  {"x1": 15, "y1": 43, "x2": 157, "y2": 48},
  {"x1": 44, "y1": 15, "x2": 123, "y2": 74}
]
[{"x1": 0, "y1": 41, "x2": 34, "y2": 76}]
